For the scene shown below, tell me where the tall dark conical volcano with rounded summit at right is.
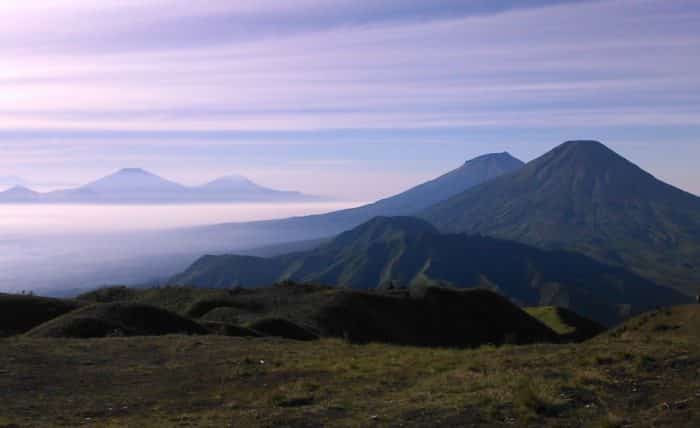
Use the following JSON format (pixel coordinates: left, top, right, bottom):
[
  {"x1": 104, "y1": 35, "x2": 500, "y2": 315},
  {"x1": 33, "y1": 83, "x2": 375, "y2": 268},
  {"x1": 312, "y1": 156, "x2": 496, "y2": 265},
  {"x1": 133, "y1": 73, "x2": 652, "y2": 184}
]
[{"x1": 422, "y1": 141, "x2": 700, "y2": 294}]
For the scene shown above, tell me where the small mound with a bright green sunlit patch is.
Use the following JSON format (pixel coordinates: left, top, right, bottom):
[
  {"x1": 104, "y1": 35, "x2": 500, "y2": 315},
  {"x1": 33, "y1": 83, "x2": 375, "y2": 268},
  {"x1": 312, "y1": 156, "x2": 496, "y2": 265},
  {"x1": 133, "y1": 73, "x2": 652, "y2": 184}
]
[{"x1": 525, "y1": 306, "x2": 605, "y2": 342}]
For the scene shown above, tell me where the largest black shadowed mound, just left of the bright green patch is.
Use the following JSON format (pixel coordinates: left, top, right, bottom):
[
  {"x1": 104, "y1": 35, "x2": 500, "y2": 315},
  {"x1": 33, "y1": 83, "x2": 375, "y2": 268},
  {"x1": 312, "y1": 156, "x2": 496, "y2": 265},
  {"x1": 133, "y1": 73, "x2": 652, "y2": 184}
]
[{"x1": 316, "y1": 287, "x2": 557, "y2": 347}]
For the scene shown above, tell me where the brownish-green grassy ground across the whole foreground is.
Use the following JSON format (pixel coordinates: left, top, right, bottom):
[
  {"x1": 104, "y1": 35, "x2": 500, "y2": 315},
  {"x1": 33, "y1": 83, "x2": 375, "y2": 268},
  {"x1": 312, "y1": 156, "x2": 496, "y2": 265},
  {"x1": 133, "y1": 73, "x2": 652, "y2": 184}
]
[{"x1": 0, "y1": 307, "x2": 700, "y2": 427}]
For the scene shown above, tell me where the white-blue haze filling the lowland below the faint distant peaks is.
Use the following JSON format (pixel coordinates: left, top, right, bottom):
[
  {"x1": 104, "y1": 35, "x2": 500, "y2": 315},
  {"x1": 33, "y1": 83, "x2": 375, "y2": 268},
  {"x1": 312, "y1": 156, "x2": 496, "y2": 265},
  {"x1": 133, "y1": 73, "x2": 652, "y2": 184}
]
[{"x1": 0, "y1": 202, "x2": 358, "y2": 292}]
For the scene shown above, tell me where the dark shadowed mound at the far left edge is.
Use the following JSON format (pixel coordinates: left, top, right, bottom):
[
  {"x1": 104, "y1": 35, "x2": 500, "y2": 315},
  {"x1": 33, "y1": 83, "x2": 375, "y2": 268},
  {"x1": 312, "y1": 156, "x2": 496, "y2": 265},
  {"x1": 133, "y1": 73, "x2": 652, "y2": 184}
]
[{"x1": 0, "y1": 294, "x2": 82, "y2": 337}]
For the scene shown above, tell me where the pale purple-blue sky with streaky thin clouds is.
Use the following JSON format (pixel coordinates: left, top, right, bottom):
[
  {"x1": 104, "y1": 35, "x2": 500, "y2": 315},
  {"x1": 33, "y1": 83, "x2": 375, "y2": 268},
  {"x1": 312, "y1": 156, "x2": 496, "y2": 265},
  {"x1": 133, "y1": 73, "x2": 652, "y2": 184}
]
[{"x1": 0, "y1": 0, "x2": 700, "y2": 201}]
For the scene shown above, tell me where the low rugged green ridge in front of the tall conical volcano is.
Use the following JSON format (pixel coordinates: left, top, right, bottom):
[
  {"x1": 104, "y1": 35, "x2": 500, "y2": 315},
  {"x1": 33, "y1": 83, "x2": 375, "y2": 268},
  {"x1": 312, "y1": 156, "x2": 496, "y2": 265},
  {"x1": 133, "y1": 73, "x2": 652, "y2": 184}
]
[{"x1": 170, "y1": 217, "x2": 689, "y2": 324}]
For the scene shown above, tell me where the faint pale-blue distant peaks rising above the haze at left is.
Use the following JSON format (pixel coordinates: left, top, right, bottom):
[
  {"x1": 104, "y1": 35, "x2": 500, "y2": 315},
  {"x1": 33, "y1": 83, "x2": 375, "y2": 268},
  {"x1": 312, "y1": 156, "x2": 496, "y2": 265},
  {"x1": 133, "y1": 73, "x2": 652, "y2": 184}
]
[{"x1": 0, "y1": 168, "x2": 321, "y2": 203}]
